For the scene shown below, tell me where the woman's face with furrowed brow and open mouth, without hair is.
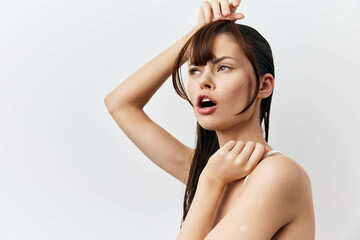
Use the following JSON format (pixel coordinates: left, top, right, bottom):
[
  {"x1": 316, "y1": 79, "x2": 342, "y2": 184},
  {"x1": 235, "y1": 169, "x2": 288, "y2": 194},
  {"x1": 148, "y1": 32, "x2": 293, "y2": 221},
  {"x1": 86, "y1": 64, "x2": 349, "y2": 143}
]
[{"x1": 187, "y1": 34, "x2": 256, "y2": 130}]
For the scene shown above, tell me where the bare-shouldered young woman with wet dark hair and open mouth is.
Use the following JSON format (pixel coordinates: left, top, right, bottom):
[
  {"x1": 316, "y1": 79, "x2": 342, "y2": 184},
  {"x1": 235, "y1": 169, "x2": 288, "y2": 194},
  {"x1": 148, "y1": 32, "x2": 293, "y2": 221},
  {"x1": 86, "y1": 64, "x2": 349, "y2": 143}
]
[{"x1": 105, "y1": 0, "x2": 315, "y2": 240}]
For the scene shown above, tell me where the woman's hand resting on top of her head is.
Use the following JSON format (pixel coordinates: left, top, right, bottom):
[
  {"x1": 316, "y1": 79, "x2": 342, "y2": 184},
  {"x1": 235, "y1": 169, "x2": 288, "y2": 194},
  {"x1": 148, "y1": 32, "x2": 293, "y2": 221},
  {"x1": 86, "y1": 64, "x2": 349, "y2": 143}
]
[{"x1": 198, "y1": 0, "x2": 245, "y2": 25}]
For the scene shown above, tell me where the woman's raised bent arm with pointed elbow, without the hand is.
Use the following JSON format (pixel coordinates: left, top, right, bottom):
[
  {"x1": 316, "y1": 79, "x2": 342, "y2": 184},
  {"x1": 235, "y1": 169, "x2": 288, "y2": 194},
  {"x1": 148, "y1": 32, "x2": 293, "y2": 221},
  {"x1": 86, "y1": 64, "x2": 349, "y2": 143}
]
[{"x1": 105, "y1": 25, "x2": 199, "y2": 184}]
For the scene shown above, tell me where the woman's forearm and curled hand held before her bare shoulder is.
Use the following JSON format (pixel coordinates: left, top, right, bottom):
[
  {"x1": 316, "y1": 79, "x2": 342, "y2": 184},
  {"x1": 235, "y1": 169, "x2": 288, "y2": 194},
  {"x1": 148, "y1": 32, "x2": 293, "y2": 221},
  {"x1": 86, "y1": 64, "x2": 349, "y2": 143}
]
[{"x1": 177, "y1": 141, "x2": 265, "y2": 240}]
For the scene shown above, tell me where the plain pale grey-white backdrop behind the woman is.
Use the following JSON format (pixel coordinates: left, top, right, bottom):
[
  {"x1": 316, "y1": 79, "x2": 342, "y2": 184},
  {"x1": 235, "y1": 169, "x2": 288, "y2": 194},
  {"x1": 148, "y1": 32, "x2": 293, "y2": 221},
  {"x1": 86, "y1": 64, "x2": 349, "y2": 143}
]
[{"x1": 0, "y1": 0, "x2": 360, "y2": 240}]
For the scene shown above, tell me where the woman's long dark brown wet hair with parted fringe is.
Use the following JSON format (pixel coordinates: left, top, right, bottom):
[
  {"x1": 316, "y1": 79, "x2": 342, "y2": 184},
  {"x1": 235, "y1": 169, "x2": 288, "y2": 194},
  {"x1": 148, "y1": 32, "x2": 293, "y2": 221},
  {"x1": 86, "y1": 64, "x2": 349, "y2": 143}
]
[{"x1": 172, "y1": 20, "x2": 275, "y2": 225}]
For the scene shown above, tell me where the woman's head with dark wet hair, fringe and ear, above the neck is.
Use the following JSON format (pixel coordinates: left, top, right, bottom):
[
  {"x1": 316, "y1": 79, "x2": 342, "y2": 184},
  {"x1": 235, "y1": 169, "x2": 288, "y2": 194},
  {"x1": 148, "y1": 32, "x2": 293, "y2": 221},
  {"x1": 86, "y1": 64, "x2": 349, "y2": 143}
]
[{"x1": 173, "y1": 20, "x2": 275, "y2": 139}]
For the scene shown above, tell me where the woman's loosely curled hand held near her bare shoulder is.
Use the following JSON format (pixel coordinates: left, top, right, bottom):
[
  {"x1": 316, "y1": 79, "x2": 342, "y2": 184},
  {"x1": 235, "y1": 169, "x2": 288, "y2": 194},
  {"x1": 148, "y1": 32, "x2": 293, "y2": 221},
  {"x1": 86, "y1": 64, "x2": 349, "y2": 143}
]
[{"x1": 201, "y1": 140, "x2": 270, "y2": 187}]
